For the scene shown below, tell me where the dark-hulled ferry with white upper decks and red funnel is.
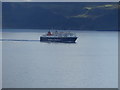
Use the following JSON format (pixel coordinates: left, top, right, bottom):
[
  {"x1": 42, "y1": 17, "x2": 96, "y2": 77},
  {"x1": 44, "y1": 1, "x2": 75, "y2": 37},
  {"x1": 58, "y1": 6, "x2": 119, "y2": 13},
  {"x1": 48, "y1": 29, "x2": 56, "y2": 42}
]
[{"x1": 40, "y1": 31, "x2": 77, "y2": 43}]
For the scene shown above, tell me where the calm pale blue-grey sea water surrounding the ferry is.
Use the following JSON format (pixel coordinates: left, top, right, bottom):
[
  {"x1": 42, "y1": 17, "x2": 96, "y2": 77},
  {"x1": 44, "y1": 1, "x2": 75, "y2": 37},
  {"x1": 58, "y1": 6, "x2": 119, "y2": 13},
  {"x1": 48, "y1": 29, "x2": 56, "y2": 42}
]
[{"x1": 2, "y1": 31, "x2": 118, "y2": 88}]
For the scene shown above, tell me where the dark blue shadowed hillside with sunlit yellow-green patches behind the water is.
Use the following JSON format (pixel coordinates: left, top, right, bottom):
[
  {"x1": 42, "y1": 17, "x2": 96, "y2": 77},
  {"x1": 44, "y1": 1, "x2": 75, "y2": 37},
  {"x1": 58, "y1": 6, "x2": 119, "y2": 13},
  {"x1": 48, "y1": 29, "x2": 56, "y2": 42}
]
[{"x1": 2, "y1": 2, "x2": 118, "y2": 30}]
